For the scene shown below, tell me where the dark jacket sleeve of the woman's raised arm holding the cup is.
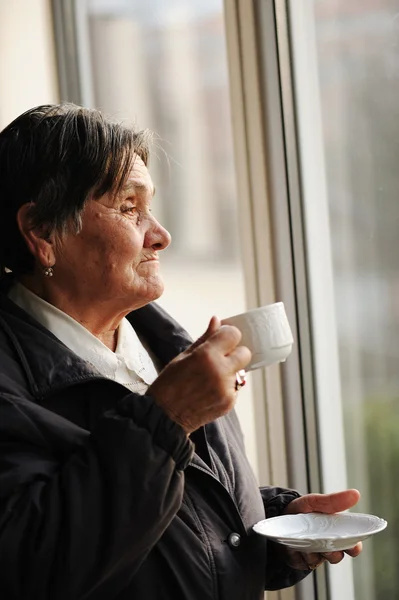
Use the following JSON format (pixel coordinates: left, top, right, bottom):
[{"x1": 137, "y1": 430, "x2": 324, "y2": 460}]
[{"x1": 0, "y1": 394, "x2": 193, "y2": 600}]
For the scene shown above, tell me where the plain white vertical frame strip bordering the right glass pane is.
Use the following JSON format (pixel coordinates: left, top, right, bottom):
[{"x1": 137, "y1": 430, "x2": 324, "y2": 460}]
[{"x1": 287, "y1": 0, "x2": 355, "y2": 600}]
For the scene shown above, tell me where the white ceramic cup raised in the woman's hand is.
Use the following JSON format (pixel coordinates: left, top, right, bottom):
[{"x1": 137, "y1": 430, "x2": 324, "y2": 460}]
[{"x1": 222, "y1": 302, "x2": 294, "y2": 371}]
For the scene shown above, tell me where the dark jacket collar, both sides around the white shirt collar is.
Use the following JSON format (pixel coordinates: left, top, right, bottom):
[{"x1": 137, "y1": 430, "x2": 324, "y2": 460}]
[{"x1": 0, "y1": 277, "x2": 191, "y2": 398}]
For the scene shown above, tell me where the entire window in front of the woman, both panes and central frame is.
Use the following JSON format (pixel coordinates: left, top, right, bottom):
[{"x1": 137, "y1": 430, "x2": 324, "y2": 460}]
[{"x1": 54, "y1": 0, "x2": 399, "y2": 600}]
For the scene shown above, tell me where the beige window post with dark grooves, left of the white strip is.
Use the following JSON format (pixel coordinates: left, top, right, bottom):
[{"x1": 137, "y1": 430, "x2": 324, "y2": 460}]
[{"x1": 225, "y1": 0, "x2": 320, "y2": 600}]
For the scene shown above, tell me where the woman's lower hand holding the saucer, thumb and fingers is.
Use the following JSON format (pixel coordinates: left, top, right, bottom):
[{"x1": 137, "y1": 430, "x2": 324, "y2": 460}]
[{"x1": 283, "y1": 490, "x2": 362, "y2": 570}]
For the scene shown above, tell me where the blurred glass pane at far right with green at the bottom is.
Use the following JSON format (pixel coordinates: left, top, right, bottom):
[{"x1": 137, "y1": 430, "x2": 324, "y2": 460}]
[{"x1": 314, "y1": 0, "x2": 399, "y2": 600}]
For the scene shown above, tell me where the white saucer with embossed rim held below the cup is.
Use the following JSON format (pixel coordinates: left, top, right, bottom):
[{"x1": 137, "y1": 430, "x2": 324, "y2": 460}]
[{"x1": 253, "y1": 512, "x2": 387, "y2": 552}]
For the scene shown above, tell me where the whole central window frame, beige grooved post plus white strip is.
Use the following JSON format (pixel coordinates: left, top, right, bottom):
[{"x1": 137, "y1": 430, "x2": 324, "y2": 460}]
[{"x1": 225, "y1": 0, "x2": 353, "y2": 600}]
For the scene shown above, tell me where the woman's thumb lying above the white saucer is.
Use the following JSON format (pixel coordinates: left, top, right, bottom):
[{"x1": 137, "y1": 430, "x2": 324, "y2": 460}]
[{"x1": 286, "y1": 490, "x2": 360, "y2": 514}]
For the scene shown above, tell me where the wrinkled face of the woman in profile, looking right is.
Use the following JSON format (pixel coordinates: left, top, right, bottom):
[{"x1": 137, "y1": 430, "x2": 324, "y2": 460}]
[{"x1": 54, "y1": 156, "x2": 171, "y2": 310}]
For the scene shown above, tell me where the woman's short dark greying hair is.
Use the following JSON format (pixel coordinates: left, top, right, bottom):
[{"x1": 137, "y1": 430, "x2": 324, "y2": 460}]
[{"x1": 0, "y1": 103, "x2": 152, "y2": 276}]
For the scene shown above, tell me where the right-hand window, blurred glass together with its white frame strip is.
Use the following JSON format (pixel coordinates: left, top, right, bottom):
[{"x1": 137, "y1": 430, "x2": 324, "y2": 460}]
[{"x1": 291, "y1": 0, "x2": 399, "y2": 600}]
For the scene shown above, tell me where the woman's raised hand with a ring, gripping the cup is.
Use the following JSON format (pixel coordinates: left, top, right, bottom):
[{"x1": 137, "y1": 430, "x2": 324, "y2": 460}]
[{"x1": 148, "y1": 317, "x2": 251, "y2": 434}]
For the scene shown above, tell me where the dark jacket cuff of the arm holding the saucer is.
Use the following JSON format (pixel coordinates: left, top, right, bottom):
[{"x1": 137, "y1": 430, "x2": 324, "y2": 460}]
[{"x1": 260, "y1": 487, "x2": 311, "y2": 591}]
